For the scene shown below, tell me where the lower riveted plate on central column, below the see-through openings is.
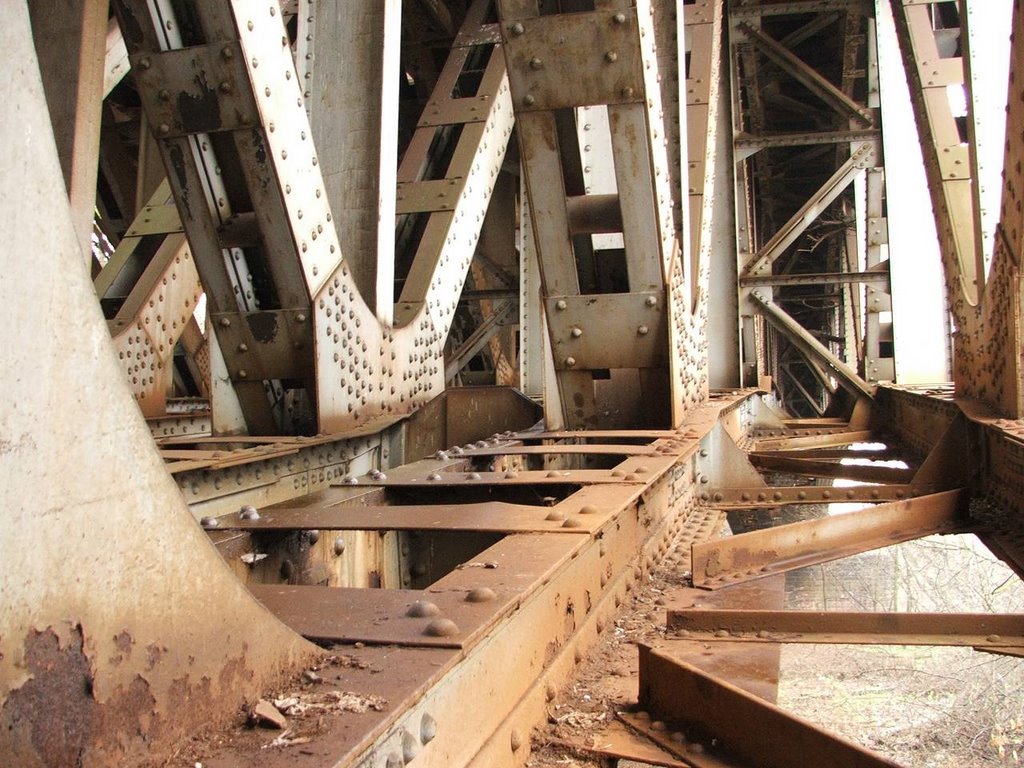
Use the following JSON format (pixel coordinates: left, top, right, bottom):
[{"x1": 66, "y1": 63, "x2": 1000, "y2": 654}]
[{"x1": 545, "y1": 292, "x2": 669, "y2": 371}]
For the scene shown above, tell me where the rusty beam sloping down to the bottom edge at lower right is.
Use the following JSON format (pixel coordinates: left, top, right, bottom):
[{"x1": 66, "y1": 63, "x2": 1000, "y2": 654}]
[{"x1": 640, "y1": 645, "x2": 898, "y2": 768}]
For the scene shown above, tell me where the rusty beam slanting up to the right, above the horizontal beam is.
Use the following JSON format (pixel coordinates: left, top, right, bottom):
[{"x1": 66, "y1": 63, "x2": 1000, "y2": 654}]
[{"x1": 691, "y1": 490, "x2": 967, "y2": 589}]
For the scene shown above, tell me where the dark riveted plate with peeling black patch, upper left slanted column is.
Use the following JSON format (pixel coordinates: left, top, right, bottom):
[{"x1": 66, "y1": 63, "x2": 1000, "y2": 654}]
[{"x1": 131, "y1": 41, "x2": 259, "y2": 138}]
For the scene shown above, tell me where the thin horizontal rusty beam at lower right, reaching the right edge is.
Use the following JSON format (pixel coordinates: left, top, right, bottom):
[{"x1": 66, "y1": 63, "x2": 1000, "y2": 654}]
[{"x1": 668, "y1": 608, "x2": 1024, "y2": 647}]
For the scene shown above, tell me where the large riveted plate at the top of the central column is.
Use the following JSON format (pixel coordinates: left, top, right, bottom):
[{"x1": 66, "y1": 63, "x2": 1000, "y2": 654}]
[{"x1": 502, "y1": 8, "x2": 644, "y2": 112}]
